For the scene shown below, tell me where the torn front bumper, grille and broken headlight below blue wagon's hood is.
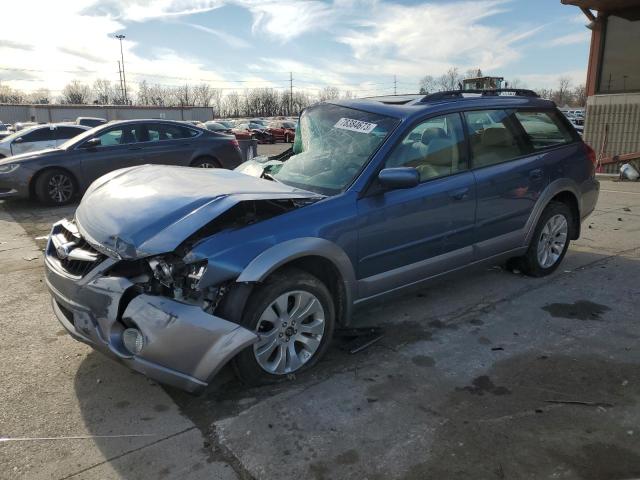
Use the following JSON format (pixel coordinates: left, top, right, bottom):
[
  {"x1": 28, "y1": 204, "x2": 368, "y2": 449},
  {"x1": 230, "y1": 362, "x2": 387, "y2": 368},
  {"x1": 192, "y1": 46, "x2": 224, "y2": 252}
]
[{"x1": 45, "y1": 221, "x2": 257, "y2": 392}]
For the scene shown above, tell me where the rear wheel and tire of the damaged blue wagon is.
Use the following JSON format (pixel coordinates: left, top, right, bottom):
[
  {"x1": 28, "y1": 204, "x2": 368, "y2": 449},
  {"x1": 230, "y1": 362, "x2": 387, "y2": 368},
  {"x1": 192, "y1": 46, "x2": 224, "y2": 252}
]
[{"x1": 509, "y1": 202, "x2": 574, "y2": 277}]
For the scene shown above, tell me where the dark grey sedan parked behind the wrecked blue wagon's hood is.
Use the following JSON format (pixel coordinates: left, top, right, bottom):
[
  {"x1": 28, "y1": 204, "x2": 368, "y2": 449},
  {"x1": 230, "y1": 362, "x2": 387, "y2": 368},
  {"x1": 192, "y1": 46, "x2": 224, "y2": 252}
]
[{"x1": 0, "y1": 120, "x2": 242, "y2": 205}]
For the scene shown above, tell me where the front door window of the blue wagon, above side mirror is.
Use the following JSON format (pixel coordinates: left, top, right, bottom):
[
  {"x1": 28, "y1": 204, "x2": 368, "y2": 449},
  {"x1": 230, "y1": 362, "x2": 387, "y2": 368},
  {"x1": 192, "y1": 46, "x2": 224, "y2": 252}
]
[{"x1": 385, "y1": 113, "x2": 467, "y2": 182}]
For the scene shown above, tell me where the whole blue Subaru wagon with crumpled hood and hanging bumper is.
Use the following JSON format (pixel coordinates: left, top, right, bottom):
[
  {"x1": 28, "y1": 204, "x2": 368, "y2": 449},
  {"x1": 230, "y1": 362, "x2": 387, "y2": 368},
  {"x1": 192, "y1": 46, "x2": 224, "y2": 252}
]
[{"x1": 45, "y1": 91, "x2": 599, "y2": 391}]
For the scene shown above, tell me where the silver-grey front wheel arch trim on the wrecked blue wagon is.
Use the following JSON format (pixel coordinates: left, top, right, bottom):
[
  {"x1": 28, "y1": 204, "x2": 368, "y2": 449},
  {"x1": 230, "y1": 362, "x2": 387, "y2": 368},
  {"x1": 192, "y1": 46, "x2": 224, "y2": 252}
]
[{"x1": 236, "y1": 237, "x2": 356, "y2": 325}]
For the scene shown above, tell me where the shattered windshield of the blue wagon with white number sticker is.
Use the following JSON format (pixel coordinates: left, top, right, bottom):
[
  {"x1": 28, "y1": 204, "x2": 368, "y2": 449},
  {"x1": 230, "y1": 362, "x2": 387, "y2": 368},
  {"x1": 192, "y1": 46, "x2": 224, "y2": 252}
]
[{"x1": 269, "y1": 103, "x2": 398, "y2": 195}]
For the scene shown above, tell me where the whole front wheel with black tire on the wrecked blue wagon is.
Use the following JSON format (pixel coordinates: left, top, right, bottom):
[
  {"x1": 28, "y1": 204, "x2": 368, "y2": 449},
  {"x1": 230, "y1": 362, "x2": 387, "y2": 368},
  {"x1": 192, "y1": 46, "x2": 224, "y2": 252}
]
[{"x1": 233, "y1": 268, "x2": 335, "y2": 385}]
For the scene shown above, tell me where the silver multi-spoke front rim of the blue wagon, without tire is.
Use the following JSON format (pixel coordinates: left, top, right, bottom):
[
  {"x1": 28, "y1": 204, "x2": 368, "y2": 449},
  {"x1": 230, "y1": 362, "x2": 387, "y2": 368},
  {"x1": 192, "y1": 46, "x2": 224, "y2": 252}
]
[{"x1": 253, "y1": 290, "x2": 325, "y2": 375}]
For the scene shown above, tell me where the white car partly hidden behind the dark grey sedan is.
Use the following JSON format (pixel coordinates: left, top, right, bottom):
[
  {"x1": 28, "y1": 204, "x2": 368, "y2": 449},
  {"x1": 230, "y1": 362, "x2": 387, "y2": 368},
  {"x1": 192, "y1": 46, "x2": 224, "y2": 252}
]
[{"x1": 0, "y1": 123, "x2": 89, "y2": 158}]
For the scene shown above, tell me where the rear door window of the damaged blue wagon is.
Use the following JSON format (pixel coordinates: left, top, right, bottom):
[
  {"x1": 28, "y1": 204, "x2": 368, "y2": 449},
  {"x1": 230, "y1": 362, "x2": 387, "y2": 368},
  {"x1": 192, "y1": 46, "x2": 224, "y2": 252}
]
[{"x1": 464, "y1": 110, "x2": 531, "y2": 167}]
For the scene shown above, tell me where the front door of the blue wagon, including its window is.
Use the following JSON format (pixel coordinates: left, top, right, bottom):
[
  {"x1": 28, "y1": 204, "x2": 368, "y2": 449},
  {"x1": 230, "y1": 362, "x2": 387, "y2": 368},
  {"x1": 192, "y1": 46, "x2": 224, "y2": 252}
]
[{"x1": 357, "y1": 114, "x2": 476, "y2": 298}]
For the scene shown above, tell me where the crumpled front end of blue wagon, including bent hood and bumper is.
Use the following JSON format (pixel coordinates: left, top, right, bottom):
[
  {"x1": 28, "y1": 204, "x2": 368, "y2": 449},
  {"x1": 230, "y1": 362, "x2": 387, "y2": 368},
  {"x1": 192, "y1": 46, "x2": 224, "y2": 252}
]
[{"x1": 45, "y1": 165, "x2": 322, "y2": 392}]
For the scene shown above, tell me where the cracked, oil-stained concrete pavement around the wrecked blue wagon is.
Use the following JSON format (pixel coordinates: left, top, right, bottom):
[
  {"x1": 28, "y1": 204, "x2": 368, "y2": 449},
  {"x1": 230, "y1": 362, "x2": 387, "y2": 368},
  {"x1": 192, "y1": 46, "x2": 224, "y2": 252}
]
[{"x1": 0, "y1": 163, "x2": 640, "y2": 480}]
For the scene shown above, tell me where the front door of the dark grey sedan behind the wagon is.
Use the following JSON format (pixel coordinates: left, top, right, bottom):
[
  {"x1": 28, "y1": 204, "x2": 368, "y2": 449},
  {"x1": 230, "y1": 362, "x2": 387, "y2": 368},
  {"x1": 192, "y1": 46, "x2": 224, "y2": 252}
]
[{"x1": 76, "y1": 123, "x2": 146, "y2": 184}]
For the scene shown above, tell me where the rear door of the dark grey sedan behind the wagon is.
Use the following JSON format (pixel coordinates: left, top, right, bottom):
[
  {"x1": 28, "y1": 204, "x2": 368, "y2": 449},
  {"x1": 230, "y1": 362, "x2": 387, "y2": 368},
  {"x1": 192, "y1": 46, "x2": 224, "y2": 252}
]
[{"x1": 143, "y1": 122, "x2": 201, "y2": 166}]
